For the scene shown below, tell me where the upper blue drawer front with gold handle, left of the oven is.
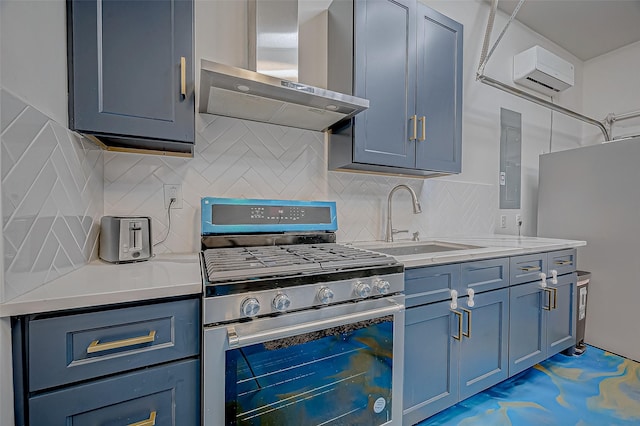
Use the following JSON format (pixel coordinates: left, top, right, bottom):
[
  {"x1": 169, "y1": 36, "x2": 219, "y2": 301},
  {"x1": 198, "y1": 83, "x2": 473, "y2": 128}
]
[{"x1": 29, "y1": 299, "x2": 201, "y2": 392}]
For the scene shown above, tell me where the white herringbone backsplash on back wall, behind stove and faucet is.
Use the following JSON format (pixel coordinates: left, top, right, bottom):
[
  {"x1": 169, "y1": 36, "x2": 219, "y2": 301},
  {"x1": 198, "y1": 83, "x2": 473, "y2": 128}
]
[{"x1": 104, "y1": 114, "x2": 498, "y2": 252}]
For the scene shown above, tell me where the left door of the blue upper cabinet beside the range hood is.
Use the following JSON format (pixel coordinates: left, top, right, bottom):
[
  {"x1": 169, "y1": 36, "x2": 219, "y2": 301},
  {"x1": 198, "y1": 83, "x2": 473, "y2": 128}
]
[{"x1": 353, "y1": 0, "x2": 416, "y2": 168}]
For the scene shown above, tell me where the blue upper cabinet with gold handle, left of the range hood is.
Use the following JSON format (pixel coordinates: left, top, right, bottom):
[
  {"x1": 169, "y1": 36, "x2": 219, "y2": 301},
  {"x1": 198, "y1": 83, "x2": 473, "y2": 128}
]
[{"x1": 67, "y1": 0, "x2": 195, "y2": 154}]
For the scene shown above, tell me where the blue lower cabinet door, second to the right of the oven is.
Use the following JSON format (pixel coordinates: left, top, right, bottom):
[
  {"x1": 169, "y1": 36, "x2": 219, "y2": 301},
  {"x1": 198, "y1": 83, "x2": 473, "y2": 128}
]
[{"x1": 458, "y1": 288, "x2": 509, "y2": 400}]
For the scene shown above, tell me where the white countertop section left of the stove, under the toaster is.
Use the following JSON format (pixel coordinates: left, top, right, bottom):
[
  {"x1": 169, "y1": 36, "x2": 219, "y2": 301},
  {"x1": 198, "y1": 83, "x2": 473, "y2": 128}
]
[{"x1": 0, "y1": 253, "x2": 202, "y2": 317}]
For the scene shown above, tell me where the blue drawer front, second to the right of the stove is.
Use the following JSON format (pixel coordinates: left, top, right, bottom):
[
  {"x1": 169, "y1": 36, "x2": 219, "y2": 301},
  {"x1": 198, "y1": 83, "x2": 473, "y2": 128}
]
[{"x1": 461, "y1": 258, "x2": 509, "y2": 295}]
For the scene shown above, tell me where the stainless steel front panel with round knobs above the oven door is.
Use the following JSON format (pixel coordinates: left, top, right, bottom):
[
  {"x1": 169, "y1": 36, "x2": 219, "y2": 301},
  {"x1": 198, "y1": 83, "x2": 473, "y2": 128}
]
[{"x1": 203, "y1": 273, "x2": 404, "y2": 324}]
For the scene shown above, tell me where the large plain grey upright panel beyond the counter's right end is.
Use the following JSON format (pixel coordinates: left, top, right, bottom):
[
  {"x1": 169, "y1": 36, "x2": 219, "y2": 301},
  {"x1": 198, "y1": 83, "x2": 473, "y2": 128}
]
[{"x1": 538, "y1": 138, "x2": 640, "y2": 361}]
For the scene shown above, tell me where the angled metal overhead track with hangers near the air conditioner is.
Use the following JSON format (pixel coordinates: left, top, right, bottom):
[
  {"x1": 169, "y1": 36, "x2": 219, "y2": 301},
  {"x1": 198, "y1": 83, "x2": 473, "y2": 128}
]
[{"x1": 476, "y1": 0, "x2": 608, "y2": 141}]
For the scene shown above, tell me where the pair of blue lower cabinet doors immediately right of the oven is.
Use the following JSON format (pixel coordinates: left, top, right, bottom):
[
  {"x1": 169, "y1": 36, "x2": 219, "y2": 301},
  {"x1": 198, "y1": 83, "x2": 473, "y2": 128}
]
[{"x1": 403, "y1": 288, "x2": 509, "y2": 425}]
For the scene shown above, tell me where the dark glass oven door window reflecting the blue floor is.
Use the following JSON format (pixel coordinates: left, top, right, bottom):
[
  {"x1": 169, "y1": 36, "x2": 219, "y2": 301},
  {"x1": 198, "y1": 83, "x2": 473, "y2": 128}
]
[{"x1": 225, "y1": 316, "x2": 393, "y2": 426}]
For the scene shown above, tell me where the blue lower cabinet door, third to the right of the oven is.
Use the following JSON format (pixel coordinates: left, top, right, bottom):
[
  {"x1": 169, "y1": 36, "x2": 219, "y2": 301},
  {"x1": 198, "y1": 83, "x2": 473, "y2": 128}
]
[{"x1": 509, "y1": 282, "x2": 548, "y2": 376}]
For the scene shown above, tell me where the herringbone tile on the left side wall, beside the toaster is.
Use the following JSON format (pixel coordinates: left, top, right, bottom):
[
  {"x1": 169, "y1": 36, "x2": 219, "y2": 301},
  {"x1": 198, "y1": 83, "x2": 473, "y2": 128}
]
[{"x1": 0, "y1": 89, "x2": 104, "y2": 301}]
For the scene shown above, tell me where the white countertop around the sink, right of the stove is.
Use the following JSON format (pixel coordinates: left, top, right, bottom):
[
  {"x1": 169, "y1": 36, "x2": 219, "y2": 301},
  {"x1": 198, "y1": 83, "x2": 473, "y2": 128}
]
[{"x1": 352, "y1": 235, "x2": 587, "y2": 268}]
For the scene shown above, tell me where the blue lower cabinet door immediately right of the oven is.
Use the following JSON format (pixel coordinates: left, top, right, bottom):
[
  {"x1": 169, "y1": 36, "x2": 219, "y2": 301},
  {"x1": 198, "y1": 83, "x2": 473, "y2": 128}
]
[{"x1": 403, "y1": 301, "x2": 459, "y2": 425}]
